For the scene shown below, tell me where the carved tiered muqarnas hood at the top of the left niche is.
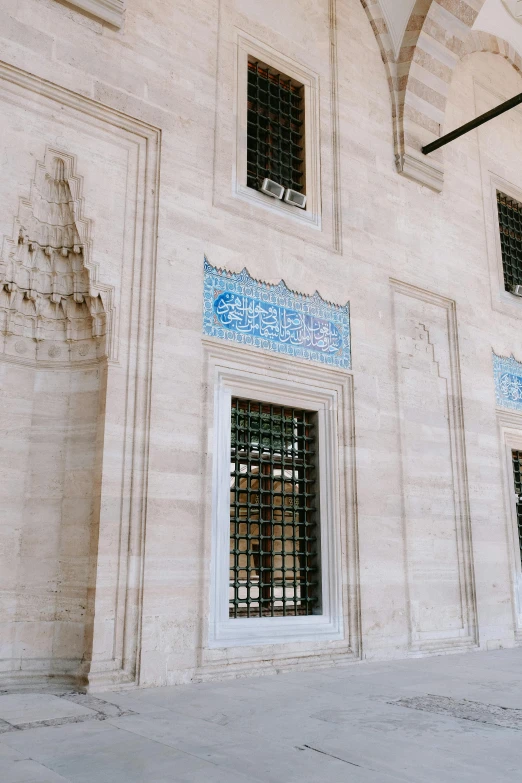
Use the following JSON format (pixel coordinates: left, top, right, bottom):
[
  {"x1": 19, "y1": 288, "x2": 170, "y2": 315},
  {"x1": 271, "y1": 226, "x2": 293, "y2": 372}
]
[{"x1": 0, "y1": 149, "x2": 106, "y2": 359}]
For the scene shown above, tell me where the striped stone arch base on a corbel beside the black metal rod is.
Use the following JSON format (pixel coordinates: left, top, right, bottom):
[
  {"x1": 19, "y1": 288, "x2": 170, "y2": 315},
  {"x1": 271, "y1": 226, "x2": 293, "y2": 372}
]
[{"x1": 361, "y1": 0, "x2": 494, "y2": 191}]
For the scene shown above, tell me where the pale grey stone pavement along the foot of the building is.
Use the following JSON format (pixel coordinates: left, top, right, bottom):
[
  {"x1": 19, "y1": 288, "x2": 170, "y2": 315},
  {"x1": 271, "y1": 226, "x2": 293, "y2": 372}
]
[{"x1": 0, "y1": 649, "x2": 522, "y2": 783}]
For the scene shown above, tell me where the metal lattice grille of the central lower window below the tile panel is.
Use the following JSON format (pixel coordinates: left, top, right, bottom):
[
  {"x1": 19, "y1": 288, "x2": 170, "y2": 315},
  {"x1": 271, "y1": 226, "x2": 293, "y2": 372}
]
[{"x1": 229, "y1": 398, "x2": 320, "y2": 617}]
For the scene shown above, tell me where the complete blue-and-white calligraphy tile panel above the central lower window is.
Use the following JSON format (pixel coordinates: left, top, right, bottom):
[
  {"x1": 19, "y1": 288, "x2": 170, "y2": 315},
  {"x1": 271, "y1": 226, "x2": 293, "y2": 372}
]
[{"x1": 203, "y1": 258, "x2": 351, "y2": 369}]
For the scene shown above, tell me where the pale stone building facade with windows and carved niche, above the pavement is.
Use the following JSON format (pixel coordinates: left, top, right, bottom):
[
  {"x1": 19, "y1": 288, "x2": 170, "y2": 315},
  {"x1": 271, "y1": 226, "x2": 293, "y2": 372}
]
[{"x1": 0, "y1": 0, "x2": 522, "y2": 690}]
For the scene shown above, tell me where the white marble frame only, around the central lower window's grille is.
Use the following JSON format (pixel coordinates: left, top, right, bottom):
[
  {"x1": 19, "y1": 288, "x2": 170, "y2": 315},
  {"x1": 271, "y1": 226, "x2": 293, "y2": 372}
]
[{"x1": 208, "y1": 352, "x2": 344, "y2": 648}]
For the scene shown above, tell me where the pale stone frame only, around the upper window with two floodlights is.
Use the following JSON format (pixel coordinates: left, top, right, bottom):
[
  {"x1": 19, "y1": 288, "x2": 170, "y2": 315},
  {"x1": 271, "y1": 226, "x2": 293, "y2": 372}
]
[{"x1": 233, "y1": 31, "x2": 321, "y2": 229}]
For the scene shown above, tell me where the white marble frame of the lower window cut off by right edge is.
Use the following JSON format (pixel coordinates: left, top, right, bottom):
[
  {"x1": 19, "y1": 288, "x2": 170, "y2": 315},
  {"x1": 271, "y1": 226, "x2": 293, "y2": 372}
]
[{"x1": 497, "y1": 409, "x2": 522, "y2": 643}]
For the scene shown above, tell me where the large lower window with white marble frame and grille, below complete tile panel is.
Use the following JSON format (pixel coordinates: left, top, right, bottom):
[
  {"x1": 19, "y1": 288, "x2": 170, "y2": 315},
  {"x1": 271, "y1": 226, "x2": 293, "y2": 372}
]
[{"x1": 208, "y1": 356, "x2": 344, "y2": 648}]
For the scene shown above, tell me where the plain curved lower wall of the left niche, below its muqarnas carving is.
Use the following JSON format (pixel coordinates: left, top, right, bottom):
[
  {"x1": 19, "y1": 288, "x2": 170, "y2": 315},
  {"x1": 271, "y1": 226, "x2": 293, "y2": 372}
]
[{"x1": 0, "y1": 361, "x2": 100, "y2": 676}]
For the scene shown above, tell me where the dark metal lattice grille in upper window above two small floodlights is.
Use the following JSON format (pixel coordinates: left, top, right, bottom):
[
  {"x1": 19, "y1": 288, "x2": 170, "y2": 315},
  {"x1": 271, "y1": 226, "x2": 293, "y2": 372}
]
[{"x1": 247, "y1": 62, "x2": 305, "y2": 193}]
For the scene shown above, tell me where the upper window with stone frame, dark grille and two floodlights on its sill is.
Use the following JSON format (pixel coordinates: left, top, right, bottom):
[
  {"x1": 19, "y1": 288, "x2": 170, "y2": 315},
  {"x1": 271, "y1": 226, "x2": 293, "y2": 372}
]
[{"x1": 228, "y1": 33, "x2": 320, "y2": 230}]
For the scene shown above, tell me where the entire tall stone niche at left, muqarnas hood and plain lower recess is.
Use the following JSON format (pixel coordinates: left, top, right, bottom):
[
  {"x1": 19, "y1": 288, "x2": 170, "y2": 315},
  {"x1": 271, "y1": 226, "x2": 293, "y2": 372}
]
[{"x1": 0, "y1": 149, "x2": 106, "y2": 688}]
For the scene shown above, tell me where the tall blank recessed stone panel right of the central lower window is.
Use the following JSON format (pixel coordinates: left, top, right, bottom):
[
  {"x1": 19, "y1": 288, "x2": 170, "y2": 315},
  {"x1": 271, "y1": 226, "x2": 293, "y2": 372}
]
[{"x1": 391, "y1": 280, "x2": 476, "y2": 653}]
